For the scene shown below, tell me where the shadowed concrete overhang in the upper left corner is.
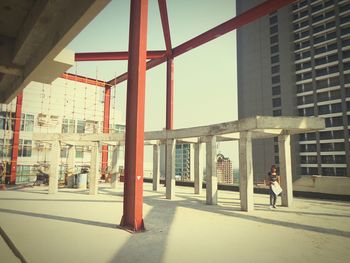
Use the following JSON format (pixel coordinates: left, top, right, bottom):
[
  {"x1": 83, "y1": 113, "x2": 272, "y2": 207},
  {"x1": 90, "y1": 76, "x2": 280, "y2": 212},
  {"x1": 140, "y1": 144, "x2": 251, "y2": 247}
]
[{"x1": 0, "y1": 0, "x2": 111, "y2": 103}]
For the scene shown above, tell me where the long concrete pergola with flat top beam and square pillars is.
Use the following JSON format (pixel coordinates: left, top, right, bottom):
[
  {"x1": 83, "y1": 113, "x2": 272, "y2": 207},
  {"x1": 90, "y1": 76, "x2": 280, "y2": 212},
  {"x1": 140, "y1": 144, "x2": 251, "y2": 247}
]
[{"x1": 33, "y1": 116, "x2": 325, "y2": 211}]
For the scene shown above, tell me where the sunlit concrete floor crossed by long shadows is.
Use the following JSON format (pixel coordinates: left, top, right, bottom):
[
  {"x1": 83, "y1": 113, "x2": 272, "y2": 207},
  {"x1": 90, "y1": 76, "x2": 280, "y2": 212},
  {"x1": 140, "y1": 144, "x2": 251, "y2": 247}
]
[{"x1": 0, "y1": 184, "x2": 350, "y2": 263}]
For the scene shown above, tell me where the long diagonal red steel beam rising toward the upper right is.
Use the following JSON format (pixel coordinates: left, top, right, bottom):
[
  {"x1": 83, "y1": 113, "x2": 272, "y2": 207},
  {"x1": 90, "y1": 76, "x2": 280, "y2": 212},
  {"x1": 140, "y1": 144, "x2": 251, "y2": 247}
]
[{"x1": 107, "y1": 0, "x2": 296, "y2": 85}]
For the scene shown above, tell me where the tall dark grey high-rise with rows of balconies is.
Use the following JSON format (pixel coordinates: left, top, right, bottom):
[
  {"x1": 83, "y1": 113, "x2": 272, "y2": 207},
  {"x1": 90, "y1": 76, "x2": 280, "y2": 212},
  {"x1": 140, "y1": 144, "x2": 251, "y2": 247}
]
[{"x1": 236, "y1": 0, "x2": 350, "y2": 182}]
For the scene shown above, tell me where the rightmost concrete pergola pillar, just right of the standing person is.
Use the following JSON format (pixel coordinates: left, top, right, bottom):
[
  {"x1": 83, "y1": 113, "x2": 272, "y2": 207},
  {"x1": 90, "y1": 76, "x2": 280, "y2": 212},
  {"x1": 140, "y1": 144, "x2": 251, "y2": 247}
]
[{"x1": 278, "y1": 134, "x2": 293, "y2": 207}]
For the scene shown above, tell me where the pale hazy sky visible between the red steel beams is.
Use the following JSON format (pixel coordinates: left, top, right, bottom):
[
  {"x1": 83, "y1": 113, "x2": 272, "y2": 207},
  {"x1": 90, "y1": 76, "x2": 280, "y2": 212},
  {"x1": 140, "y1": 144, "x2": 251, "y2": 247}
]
[{"x1": 67, "y1": 0, "x2": 238, "y2": 167}]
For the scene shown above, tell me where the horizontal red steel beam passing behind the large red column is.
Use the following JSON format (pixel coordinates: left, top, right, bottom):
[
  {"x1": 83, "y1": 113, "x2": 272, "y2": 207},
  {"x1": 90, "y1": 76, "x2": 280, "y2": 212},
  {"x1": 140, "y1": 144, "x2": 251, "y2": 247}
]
[{"x1": 75, "y1": 50, "x2": 165, "y2": 61}]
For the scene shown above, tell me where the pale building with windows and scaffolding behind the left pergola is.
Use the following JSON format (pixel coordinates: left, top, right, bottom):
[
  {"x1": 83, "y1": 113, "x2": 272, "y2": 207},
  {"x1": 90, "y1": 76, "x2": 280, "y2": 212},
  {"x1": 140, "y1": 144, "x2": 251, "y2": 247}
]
[{"x1": 0, "y1": 78, "x2": 125, "y2": 183}]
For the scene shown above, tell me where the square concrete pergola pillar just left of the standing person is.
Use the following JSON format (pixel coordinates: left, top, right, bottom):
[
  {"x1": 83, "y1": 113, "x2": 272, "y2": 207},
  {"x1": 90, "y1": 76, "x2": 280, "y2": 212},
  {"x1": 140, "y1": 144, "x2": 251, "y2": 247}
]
[{"x1": 239, "y1": 132, "x2": 254, "y2": 212}]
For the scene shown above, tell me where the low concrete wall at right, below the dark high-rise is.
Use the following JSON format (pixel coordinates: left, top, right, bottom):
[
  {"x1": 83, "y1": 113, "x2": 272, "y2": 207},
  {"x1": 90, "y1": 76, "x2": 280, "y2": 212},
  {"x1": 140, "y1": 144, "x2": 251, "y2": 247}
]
[{"x1": 293, "y1": 175, "x2": 350, "y2": 195}]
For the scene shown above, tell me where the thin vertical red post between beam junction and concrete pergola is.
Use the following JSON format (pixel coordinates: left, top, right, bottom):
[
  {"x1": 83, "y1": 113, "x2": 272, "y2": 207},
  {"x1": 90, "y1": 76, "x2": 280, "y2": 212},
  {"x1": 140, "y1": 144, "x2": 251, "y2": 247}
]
[{"x1": 166, "y1": 58, "x2": 174, "y2": 130}]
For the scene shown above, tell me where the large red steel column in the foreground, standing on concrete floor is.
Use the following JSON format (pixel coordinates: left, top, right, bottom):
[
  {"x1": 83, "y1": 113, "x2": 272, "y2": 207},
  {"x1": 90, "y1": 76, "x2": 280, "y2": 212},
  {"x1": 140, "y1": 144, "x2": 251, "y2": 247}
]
[{"x1": 120, "y1": 0, "x2": 148, "y2": 231}]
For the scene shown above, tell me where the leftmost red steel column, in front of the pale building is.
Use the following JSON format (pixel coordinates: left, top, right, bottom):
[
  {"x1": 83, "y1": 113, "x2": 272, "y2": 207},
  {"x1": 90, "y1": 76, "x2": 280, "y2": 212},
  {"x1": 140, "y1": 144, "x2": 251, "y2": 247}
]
[{"x1": 10, "y1": 91, "x2": 23, "y2": 184}]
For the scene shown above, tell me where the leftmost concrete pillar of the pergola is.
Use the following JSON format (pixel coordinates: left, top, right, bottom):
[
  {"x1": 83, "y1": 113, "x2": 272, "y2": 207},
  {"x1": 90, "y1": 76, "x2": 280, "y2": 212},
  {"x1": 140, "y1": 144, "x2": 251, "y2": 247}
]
[{"x1": 49, "y1": 141, "x2": 61, "y2": 194}]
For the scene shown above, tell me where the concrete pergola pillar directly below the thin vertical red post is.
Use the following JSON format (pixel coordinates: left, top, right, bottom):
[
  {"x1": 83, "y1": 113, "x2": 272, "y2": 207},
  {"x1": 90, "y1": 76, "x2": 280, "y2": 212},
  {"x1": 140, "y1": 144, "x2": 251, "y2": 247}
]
[{"x1": 165, "y1": 139, "x2": 176, "y2": 199}]
